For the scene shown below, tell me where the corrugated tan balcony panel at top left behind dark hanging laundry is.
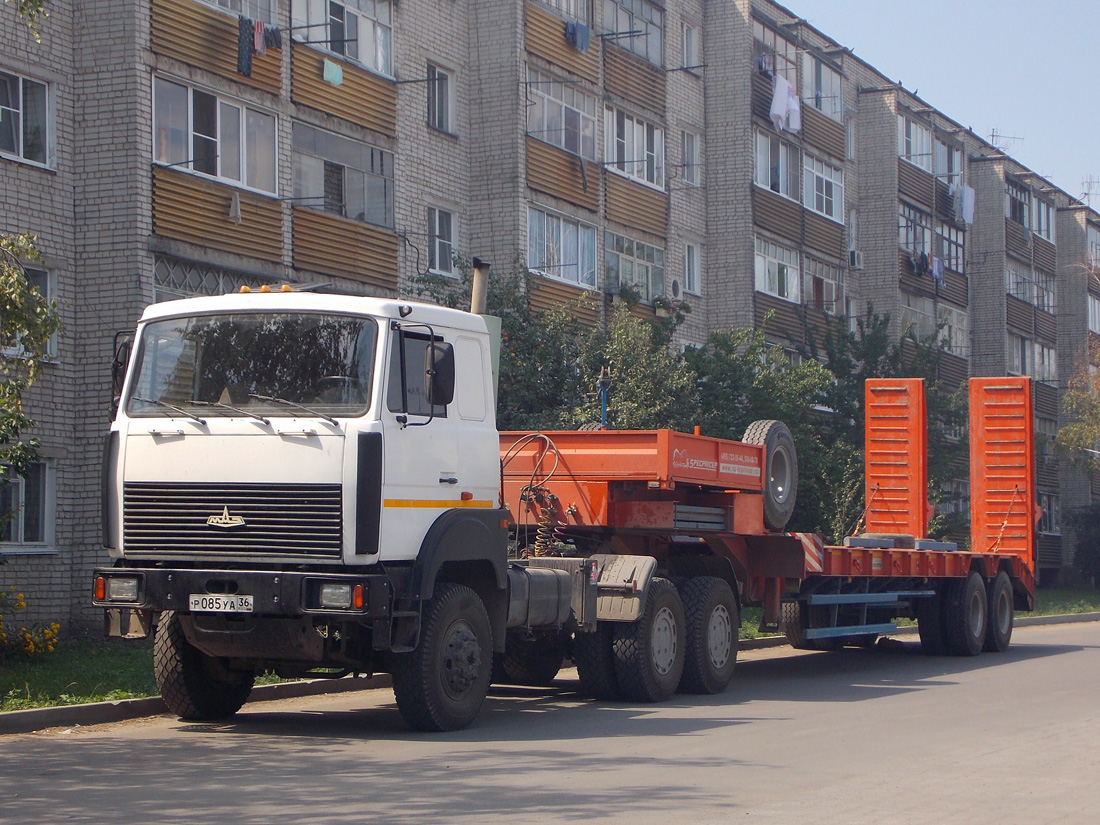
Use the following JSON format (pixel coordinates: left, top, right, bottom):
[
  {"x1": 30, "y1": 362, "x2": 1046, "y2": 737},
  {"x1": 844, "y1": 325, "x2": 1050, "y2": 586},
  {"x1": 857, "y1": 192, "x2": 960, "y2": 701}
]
[{"x1": 150, "y1": 0, "x2": 283, "y2": 95}]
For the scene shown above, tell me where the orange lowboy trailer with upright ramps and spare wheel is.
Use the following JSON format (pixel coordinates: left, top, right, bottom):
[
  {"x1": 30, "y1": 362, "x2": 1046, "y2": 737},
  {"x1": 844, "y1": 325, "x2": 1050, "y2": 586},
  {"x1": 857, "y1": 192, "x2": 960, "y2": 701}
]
[{"x1": 501, "y1": 378, "x2": 1038, "y2": 655}]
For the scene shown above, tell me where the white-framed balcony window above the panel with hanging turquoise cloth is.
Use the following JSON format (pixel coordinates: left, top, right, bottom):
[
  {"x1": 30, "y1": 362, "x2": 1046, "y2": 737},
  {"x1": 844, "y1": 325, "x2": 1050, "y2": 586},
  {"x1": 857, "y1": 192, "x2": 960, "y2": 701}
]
[{"x1": 290, "y1": 0, "x2": 393, "y2": 75}]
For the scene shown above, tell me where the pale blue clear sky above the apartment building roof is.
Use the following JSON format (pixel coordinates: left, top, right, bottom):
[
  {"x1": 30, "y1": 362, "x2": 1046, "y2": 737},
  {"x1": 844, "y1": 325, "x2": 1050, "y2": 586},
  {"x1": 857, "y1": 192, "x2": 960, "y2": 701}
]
[{"x1": 796, "y1": 0, "x2": 1100, "y2": 203}]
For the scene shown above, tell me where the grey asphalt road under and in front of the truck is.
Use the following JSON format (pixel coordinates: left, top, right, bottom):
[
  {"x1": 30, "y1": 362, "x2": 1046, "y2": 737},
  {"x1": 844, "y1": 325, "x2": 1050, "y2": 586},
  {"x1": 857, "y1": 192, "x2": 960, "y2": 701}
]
[{"x1": 0, "y1": 622, "x2": 1100, "y2": 825}]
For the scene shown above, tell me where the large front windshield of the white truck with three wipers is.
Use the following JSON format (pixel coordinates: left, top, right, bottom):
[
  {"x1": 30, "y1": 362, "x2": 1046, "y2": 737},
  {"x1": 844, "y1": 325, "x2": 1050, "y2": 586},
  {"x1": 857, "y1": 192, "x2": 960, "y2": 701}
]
[{"x1": 125, "y1": 312, "x2": 377, "y2": 418}]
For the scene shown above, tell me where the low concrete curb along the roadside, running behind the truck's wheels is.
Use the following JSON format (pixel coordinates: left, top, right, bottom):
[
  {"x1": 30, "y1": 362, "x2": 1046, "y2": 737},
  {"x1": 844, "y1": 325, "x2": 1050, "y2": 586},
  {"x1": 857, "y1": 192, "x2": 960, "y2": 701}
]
[{"x1": 0, "y1": 613, "x2": 1100, "y2": 735}]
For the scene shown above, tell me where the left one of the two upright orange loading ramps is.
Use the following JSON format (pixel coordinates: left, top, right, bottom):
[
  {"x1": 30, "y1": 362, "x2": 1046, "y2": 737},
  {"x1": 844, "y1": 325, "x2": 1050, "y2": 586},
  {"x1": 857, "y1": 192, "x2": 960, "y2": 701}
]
[{"x1": 864, "y1": 378, "x2": 932, "y2": 538}]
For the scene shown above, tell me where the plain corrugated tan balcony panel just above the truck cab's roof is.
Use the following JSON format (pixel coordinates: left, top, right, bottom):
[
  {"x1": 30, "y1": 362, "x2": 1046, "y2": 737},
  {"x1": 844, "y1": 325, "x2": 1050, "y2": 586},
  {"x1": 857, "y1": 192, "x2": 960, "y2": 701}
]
[{"x1": 294, "y1": 207, "x2": 398, "y2": 289}]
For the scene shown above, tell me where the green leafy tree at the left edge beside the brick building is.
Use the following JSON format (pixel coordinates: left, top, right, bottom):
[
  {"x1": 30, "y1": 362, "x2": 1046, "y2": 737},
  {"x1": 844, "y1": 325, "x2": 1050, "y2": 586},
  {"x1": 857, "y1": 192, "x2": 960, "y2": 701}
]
[{"x1": 0, "y1": 234, "x2": 61, "y2": 517}]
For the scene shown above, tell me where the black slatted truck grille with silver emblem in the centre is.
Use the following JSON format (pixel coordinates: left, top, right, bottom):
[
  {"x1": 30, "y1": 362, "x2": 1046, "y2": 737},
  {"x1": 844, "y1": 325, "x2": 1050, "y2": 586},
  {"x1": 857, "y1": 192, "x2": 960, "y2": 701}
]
[{"x1": 122, "y1": 483, "x2": 341, "y2": 556}]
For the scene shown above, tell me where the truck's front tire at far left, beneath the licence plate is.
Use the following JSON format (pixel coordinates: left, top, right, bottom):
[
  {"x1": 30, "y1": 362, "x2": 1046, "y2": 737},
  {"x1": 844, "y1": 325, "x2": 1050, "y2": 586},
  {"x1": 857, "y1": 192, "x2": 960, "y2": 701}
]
[{"x1": 153, "y1": 611, "x2": 255, "y2": 722}]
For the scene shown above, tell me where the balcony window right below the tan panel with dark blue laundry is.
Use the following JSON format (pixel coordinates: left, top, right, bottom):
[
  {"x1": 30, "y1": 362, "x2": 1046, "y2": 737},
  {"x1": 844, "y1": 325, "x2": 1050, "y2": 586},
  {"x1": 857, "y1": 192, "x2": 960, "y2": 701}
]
[{"x1": 527, "y1": 68, "x2": 596, "y2": 161}]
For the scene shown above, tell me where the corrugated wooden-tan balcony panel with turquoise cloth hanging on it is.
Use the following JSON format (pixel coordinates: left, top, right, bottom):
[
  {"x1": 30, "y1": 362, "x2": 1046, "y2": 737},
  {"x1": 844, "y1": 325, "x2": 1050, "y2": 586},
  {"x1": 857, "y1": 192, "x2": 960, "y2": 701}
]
[{"x1": 290, "y1": 43, "x2": 398, "y2": 136}]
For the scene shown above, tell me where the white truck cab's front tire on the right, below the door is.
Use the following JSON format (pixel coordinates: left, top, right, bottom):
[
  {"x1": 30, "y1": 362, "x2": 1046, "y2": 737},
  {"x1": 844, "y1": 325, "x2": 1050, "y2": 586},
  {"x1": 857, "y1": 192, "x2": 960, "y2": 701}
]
[{"x1": 391, "y1": 582, "x2": 493, "y2": 732}]
